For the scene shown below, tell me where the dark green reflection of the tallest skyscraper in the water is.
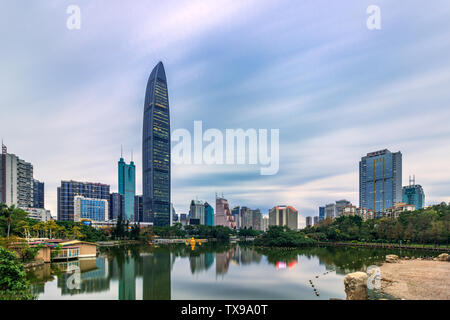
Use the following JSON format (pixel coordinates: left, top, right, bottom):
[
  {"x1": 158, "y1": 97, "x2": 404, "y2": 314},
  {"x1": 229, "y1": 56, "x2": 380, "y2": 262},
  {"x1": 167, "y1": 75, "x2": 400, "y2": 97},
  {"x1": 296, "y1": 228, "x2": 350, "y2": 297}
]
[{"x1": 142, "y1": 250, "x2": 172, "y2": 300}]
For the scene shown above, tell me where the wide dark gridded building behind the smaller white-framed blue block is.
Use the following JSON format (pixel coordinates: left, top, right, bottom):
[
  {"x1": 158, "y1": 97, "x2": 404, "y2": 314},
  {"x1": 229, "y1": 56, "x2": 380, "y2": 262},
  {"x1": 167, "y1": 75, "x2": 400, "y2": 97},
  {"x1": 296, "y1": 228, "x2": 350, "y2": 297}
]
[{"x1": 57, "y1": 181, "x2": 110, "y2": 221}]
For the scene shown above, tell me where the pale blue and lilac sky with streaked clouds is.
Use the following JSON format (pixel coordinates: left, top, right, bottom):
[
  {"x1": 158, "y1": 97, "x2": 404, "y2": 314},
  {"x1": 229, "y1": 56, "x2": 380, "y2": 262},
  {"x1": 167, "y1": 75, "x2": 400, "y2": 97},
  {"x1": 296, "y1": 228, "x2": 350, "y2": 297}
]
[{"x1": 0, "y1": 0, "x2": 450, "y2": 225}]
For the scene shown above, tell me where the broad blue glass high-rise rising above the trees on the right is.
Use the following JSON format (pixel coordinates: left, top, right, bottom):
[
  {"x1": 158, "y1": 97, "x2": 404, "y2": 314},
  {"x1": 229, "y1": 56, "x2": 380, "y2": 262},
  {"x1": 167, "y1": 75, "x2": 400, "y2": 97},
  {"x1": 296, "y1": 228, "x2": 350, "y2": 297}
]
[{"x1": 359, "y1": 149, "x2": 402, "y2": 216}]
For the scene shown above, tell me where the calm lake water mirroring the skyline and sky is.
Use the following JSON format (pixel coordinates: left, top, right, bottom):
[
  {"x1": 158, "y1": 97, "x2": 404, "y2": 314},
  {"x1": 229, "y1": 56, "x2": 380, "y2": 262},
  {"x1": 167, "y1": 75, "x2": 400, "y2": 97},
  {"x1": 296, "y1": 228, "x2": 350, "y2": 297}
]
[{"x1": 28, "y1": 244, "x2": 433, "y2": 300}]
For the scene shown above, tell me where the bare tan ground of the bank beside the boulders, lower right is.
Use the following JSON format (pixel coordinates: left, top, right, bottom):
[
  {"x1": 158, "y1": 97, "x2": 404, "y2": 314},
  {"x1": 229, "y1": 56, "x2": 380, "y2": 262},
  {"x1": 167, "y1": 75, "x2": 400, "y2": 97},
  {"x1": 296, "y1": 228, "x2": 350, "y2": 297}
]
[{"x1": 380, "y1": 259, "x2": 450, "y2": 300}]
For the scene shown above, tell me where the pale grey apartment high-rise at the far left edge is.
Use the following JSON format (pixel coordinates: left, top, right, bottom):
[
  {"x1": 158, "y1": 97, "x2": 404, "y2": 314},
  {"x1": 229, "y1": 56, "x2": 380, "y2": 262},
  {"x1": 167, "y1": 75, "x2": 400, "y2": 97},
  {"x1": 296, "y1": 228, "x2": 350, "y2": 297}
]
[{"x1": 0, "y1": 143, "x2": 34, "y2": 208}]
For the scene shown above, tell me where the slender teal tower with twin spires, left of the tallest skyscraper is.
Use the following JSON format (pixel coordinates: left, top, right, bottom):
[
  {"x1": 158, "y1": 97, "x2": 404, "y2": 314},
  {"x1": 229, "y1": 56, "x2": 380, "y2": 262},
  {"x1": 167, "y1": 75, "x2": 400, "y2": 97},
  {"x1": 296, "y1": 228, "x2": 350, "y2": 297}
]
[{"x1": 118, "y1": 157, "x2": 136, "y2": 221}]
